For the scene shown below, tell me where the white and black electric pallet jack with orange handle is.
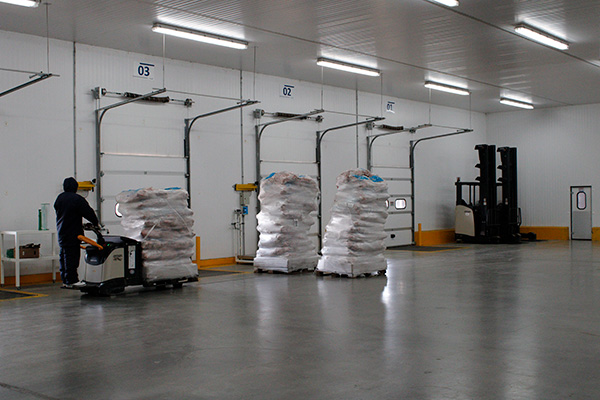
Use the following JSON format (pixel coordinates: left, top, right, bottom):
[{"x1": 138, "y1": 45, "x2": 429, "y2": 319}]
[{"x1": 77, "y1": 224, "x2": 198, "y2": 296}]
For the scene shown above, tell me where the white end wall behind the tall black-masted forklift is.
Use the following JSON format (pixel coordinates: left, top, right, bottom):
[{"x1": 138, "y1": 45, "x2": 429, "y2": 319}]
[{"x1": 487, "y1": 104, "x2": 600, "y2": 226}]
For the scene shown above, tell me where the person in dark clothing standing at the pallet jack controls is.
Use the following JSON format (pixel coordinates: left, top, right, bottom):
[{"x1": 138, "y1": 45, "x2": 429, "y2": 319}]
[{"x1": 54, "y1": 178, "x2": 98, "y2": 289}]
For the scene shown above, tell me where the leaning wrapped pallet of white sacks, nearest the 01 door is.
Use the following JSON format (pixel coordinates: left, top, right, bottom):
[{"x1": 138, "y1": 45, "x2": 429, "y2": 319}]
[{"x1": 317, "y1": 169, "x2": 389, "y2": 277}]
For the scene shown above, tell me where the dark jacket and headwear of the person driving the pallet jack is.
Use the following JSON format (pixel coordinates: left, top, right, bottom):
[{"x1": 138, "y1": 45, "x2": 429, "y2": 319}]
[{"x1": 54, "y1": 178, "x2": 98, "y2": 246}]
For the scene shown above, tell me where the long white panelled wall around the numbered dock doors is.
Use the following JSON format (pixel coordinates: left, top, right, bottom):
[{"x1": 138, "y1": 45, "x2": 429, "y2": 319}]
[{"x1": 0, "y1": 32, "x2": 486, "y2": 276}]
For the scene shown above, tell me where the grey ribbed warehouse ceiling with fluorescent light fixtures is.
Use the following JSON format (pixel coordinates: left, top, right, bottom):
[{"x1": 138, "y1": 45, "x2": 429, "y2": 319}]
[{"x1": 0, "y1": 0, "x2": 600, "y2": 112}]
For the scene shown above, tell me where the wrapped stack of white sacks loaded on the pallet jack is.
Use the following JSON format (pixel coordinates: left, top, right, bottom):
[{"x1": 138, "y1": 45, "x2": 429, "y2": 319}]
[{"x1": 117, "y1": 188, "x2": 198, "y2": 282}]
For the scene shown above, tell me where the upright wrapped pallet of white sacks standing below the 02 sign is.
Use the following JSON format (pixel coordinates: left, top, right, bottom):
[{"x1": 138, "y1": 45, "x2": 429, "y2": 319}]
[{"x1": 254, "y1": 172, "x2": 319, "y2": 272}]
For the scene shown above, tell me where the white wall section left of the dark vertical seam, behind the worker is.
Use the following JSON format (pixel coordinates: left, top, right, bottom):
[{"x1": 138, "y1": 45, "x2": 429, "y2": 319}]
[{"x1": 0, "y1": 33, "x2": 73, "y2": 230}]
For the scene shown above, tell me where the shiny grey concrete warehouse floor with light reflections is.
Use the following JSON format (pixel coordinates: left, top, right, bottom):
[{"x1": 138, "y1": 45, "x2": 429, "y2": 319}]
[{"x1": 0, "y1": 242, "x2": 600, "y2": 400}]
